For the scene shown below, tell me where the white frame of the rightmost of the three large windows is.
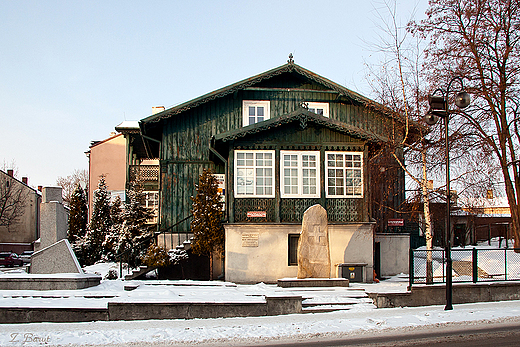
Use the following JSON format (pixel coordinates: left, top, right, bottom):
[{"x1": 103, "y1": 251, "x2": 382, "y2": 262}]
[{"x1": 324, "y1": 151, "x2": 365, "y2": 198}]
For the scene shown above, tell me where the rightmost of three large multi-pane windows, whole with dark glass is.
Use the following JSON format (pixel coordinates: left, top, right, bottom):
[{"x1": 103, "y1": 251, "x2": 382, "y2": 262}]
[{"x1": 325, "y1": 152, "x2": 363, "y2": 198}]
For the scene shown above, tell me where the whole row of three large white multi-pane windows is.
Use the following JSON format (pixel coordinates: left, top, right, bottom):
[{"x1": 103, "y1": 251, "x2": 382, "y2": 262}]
[{"x1": 234, "y1": 150, "x2": 363, "y2": 198}]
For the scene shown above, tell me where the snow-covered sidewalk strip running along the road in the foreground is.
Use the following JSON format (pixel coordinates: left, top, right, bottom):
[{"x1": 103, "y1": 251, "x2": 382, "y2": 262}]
[{"x1": 0, "y1": 301, "x2": 520, "y2": 346}]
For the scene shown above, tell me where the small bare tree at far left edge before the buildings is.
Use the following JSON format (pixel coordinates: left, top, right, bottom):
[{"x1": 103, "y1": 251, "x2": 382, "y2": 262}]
[{"x1": 0, "y1": 172, "x2": 26, "y2": 231}]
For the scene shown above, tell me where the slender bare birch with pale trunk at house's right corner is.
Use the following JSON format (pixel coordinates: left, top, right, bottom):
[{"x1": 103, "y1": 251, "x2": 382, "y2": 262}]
[{"x1": 369, "y1": 1, "x2": 439, "y2": 283}]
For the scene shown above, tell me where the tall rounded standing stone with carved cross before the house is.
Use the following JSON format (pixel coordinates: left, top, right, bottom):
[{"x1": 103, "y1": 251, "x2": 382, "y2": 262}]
[{"x1": 298, "y1": 205, "x2": 330, "y2": 278}]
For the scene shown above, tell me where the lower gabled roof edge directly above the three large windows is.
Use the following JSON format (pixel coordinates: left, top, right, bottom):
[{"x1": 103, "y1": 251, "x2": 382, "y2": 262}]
[{"x1": 215, "y1": 108, "x2": 389, "y2": 142}]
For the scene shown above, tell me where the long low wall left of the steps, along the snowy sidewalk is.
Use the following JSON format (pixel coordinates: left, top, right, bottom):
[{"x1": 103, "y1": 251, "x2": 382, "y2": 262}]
[{"x1": 0, "y1": 296, "x2": 303, "y2": 324}]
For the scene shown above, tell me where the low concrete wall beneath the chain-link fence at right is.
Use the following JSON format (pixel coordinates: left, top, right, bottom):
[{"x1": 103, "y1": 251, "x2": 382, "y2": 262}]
[{"x1": 368, "y1": 282, "x2": 520, "y2": 308}]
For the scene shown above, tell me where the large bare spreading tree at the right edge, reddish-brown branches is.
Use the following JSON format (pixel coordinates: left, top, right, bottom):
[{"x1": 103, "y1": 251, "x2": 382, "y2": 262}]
[{"x1": 410, "y1": 0, "x2": 520, "y2": 248}]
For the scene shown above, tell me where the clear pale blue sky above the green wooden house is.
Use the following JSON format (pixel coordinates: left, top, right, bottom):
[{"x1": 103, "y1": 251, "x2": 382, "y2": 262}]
[{"x1": 0, "y1": 0, "x2": 427, "y2": 186}]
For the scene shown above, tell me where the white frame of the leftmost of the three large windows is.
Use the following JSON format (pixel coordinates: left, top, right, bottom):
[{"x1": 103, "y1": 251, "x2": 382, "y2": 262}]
[{"x1": 234, "y1": 150, "x2": 276, "y2": 198}]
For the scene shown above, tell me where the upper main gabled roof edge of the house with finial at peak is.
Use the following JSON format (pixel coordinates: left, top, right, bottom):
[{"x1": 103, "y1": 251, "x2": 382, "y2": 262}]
[{"x1": 140, "y1": 60, "x2": 404, "y2": 125}]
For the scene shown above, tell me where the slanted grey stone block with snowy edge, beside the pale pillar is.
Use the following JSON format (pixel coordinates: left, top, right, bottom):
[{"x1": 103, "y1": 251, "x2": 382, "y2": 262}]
[{"x1": 31, "y1": 239, "x2": 83, "y2": 274}]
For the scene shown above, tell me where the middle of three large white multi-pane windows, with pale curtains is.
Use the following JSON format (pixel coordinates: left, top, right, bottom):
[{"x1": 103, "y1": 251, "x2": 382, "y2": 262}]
[{"x1": 280, "y1": 151, "x2": 320, "y2": 198}]
